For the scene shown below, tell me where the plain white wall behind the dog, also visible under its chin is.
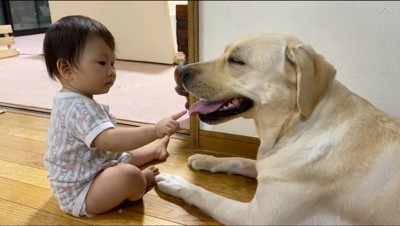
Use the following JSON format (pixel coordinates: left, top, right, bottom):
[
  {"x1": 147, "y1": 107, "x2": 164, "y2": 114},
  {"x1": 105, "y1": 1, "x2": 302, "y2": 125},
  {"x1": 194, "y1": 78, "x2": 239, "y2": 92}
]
[{"x1": 199, "y1": 1, "x2": 400, "y2": 136}]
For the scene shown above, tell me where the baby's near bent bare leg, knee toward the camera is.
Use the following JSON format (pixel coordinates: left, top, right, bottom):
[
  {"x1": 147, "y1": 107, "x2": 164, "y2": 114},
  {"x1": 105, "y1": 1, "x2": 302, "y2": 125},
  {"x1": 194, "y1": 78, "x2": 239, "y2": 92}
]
[{"x1": 85, "y1": 164, "x2": 159, "y2": 215}]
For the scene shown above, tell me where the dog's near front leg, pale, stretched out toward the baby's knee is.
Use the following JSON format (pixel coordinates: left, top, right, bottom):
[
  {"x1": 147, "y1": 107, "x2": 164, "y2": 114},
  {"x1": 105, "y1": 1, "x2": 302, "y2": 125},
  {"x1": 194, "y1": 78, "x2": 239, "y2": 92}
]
[{"x1": 156, "y1": 173, "x2": 253, "y2": 225}]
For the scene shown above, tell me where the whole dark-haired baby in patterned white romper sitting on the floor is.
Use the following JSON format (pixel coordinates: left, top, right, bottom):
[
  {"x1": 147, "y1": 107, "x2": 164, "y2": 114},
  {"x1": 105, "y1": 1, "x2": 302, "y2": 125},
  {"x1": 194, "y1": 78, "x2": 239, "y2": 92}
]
[{"x1": 43, "y1": 16, "x2": 186, "y2": 217}]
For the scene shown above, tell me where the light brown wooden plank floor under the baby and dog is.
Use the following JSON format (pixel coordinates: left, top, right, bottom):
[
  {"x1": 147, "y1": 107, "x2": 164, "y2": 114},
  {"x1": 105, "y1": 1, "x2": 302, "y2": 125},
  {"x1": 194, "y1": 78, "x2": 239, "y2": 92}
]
[{"x1": 0, "y1": 111, "x2": 256, "y2": 225}]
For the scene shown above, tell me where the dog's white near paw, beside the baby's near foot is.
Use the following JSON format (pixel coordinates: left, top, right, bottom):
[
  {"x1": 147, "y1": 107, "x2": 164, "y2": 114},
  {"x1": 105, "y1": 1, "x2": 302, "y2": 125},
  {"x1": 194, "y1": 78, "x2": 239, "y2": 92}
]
[{"x1": 155, "y1": 173, "x2": 191, "y2": 198}]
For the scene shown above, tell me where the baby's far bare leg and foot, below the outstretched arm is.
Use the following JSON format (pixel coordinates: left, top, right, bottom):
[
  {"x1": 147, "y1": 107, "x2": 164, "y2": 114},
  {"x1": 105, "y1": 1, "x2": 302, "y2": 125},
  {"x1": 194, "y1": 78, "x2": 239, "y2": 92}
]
[{"x1": 128, "y1": 136, "x2": 169, "y2": 167}]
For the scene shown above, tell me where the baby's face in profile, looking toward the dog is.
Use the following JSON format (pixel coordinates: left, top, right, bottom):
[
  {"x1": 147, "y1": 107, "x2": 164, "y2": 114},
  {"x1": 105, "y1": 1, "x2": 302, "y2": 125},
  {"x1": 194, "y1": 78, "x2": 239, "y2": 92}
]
[{"x1": 70, "y1": 36, "x2": 116, "y2": 98}]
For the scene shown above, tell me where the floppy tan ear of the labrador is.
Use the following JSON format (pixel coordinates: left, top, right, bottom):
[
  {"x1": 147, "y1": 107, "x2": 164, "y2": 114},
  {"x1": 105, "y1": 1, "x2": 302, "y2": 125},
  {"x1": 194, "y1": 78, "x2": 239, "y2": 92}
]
[{"x1": 286, "y1": 44, "x2": 336, "y2": 117}]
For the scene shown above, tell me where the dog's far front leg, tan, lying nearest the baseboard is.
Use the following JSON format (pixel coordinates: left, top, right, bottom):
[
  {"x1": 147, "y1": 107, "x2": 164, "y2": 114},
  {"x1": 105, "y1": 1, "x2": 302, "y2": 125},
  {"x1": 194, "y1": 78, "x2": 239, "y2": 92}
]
[{"x1": 188, "y1": 154, "x2": 257, "y2": 178}]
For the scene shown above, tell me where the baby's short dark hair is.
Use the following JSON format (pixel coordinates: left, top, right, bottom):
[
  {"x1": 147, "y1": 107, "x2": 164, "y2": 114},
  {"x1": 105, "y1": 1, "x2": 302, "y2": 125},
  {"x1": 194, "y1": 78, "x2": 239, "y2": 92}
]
[{"x1": 43, "y1": 15, "x2": 115, "y2": 80}]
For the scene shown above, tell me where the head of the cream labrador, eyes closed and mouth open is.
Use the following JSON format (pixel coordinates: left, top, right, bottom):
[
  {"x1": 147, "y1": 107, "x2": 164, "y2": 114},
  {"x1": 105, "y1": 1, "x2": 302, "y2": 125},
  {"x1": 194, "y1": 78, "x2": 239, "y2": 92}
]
[{"x1": 176, "y1": 34, "x2": 336, "y2": 124}]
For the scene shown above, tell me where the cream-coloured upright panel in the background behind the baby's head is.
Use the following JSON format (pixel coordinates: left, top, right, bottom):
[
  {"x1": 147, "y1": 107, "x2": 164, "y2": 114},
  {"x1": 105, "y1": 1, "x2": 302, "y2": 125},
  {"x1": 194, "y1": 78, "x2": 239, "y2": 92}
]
[{"x1": 49, "y1": 1, "x2": 177, "y2": 64}]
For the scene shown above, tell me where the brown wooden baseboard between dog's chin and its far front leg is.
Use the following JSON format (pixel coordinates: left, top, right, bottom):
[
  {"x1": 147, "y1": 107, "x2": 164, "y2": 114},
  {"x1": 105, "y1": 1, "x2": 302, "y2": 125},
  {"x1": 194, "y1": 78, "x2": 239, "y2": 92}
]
[{"x1": 199, "y1": 130, "x2": 260, "y2": 159}]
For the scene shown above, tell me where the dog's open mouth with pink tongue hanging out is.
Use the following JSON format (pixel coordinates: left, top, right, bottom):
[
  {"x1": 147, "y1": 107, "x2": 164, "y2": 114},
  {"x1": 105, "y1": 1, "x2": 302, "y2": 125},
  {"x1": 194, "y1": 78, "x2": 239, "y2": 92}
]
[{"x1": 189, "y1": 97, "x2": 253, "y2": 124}]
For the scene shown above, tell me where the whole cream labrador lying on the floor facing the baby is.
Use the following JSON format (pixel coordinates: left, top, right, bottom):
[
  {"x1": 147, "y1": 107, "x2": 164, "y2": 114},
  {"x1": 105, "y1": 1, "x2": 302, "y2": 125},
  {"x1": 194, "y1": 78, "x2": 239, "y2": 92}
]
[{"x1": 156, "y1": 34, "x2": 400, "y2": 225}]
